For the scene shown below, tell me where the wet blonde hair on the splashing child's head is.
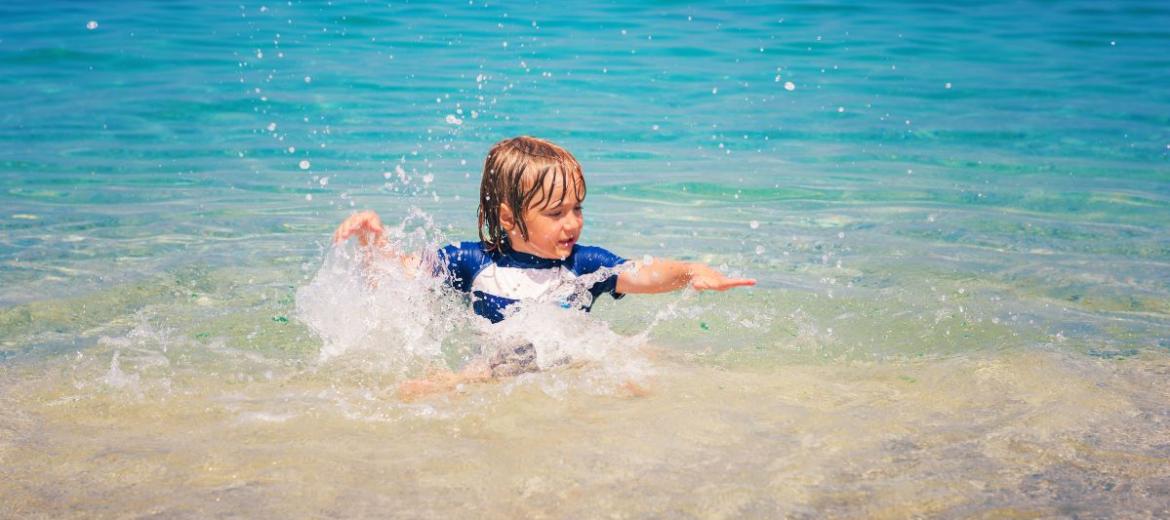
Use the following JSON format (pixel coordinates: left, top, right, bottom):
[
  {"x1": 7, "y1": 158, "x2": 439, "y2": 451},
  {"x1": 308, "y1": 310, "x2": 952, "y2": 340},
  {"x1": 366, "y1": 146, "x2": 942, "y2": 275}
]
[{"x1": 479, "y1": 136, "x2": 585, "y2": 251}]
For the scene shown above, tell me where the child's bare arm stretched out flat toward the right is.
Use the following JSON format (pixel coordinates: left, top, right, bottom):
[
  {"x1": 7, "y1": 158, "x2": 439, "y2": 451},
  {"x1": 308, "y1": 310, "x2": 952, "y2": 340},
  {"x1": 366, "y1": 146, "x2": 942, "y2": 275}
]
[{"x1": 617, "y1": 259, "x2": 756, "y2": 294}]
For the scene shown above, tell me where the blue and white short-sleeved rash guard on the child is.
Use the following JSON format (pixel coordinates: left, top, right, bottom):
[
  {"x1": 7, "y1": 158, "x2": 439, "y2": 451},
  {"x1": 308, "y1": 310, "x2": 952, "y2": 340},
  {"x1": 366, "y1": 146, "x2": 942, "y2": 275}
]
[{"x1": 439, "y1": 242, "x2": 626, "y2": 323}]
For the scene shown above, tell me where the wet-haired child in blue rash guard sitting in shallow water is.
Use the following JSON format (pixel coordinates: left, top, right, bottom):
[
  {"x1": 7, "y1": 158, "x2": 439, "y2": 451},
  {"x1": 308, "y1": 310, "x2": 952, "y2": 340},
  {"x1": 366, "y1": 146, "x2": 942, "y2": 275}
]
[{"x1": 333, "y1": 136, "x2": 756, "y2": 395}]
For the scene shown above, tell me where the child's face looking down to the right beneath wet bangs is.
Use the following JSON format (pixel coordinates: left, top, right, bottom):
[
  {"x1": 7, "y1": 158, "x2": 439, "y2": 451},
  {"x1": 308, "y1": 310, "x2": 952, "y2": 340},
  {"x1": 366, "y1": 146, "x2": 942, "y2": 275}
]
[{"x1": 501, "y1": 176, "x2": 585, "y2": 259}]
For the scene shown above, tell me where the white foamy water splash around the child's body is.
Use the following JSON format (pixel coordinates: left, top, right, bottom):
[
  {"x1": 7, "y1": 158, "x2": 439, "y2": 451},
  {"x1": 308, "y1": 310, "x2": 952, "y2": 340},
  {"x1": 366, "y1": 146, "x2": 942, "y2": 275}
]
[{"x1": 295, "y1": 208, "x2": 652, "y2": 391}]
